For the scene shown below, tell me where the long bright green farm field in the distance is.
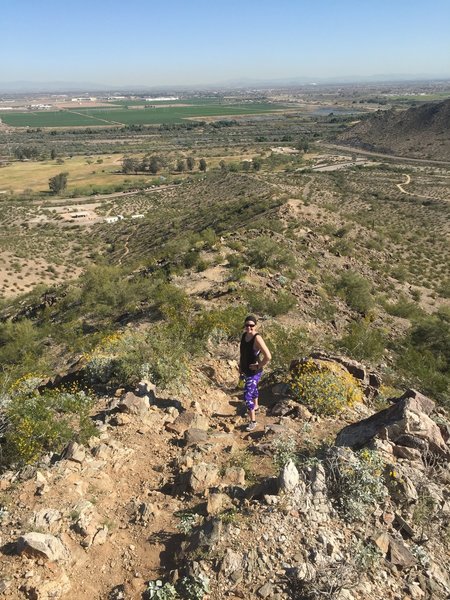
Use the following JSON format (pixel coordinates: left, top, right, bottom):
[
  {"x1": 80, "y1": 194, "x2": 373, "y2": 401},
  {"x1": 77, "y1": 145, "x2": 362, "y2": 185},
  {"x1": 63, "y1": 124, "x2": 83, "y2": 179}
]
[{"x1": 0, "y1": 102, "x2": 284, "y2": 127}]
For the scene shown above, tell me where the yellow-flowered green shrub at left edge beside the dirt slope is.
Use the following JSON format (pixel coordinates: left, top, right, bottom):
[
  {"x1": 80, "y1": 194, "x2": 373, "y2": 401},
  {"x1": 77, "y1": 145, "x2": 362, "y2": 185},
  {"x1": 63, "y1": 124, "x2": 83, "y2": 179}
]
[{"x1": 4, "y1": 389, "x2": 96, "y2": 464}]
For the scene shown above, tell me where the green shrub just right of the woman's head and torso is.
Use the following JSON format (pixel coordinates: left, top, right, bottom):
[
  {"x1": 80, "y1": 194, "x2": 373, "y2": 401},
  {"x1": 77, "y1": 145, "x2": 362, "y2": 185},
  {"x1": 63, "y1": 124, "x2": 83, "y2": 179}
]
[{"x1": 264, "y1": 323, "x2": 311, "y2": 370}]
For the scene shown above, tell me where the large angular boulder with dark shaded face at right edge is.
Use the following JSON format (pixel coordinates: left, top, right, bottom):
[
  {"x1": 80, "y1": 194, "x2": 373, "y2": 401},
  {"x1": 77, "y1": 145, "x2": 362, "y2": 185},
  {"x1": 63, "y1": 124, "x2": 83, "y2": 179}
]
[{"x1": 336, "y1": 390, "x2": 449, "y2": 456}]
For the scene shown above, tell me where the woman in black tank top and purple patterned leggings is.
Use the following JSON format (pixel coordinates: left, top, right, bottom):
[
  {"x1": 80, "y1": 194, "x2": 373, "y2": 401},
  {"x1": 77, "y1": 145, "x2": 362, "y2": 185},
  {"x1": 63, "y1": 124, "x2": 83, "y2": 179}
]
[{"x1": 239, "y1": 315, "x2": 272, "y2": 431}]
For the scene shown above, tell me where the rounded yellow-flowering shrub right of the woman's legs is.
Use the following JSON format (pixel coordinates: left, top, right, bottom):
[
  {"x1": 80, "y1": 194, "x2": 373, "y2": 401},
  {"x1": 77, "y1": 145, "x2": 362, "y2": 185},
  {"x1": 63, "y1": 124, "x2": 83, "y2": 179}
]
[{"x1": 289, "y1": 359, "x2": 362, "y2": 416}]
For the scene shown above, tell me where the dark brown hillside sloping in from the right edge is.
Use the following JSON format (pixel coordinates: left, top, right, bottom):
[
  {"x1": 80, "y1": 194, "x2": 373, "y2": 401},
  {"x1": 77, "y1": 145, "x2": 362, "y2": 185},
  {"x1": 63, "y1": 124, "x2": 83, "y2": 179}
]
[{"x1": 338, "y1": 99, "x2": 450, "y2": 161}]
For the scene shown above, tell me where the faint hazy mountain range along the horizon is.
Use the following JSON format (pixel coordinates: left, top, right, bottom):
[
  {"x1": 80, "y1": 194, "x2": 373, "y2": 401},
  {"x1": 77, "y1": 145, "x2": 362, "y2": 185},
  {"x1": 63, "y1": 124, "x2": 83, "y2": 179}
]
[{"x1": 0, "y1": 74, "x2": 450, "y2": 94}]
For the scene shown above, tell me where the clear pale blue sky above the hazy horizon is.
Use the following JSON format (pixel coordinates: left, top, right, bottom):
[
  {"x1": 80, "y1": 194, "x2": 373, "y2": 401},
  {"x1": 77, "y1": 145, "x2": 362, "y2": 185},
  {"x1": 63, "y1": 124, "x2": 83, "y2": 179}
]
[{"x1": 0, "y1": 0, "x2": 450, "y2": 85}]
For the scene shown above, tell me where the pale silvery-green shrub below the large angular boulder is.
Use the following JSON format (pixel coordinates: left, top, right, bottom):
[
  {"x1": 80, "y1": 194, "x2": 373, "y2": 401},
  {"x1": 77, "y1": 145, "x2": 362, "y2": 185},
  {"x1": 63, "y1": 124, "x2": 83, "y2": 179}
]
[{"x1": 325, "y1": 448, "x2": 388, "y2": 521}]
